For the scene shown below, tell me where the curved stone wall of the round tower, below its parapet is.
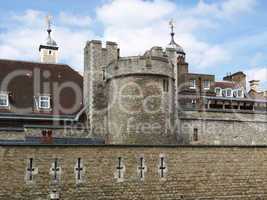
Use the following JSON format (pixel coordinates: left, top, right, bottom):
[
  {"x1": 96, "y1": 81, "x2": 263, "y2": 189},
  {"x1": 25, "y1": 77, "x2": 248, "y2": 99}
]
[{"x1": 107, "y1": 75, "x2": 177, "y2": 144}]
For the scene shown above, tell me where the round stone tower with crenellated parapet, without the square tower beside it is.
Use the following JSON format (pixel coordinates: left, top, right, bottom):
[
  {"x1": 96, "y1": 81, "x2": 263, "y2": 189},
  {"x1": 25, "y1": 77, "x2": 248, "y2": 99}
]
[{"x1": 106, "y1": 47, "x2": 176, "y2": 144}]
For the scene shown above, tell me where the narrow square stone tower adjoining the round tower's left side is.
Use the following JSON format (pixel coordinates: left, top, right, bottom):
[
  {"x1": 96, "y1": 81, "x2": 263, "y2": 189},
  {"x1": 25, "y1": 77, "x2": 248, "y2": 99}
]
[{"x1": 84, "y1": 40, "x2": 118, "y2": 140}]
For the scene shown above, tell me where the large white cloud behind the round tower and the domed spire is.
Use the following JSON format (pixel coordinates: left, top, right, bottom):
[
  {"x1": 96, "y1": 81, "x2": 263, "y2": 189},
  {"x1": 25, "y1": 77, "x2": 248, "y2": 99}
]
[{"x1": 97, "y1": 0, "x2": 242, "y2": 68}]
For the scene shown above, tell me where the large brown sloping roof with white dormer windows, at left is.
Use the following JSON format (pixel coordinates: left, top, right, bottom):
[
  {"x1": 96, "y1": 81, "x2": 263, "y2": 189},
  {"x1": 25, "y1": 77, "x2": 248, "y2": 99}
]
[{"x1": 0, "y1": 59, "x2": 83, "y2": 116}]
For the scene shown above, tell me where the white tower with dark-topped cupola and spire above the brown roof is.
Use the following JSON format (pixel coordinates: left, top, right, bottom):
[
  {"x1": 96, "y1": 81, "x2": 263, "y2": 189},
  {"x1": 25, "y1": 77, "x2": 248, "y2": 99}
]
[{"x1": 39, "y1": 16, "x2": 58, "y2": 63}]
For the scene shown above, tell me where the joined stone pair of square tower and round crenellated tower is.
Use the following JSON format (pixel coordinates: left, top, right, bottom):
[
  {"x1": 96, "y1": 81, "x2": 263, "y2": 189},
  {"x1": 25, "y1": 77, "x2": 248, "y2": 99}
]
[{"x1": 84, "y1": 40, "x2": 179, "y2": 144}]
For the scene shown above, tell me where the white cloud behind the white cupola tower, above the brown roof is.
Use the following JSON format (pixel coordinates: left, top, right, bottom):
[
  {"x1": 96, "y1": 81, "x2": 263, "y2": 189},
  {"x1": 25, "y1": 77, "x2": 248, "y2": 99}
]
[{"x1": 0, "y1": 10, "x2": 96, "y2": 72}]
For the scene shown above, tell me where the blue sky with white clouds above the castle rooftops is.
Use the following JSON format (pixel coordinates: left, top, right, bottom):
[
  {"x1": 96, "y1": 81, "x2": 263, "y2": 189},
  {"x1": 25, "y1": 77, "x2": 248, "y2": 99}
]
[{"x1": 0, "y1": 0, "x2": 267, "y2": 89}]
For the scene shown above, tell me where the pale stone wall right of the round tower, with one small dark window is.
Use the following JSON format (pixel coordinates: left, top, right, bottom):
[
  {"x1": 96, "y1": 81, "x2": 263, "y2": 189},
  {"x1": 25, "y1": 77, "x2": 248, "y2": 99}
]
[{"x1": 179, "y1": 111, "x2": 267, "y2": 145}]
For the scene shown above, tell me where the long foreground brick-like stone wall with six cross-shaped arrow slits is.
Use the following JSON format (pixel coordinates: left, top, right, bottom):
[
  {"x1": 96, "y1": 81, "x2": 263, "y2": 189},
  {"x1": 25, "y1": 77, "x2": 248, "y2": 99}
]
[{"x1": 0, "y1": 146, "x2": 267, "y2": 200}]
